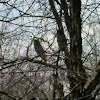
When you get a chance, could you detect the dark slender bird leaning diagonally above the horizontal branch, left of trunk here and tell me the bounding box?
[34,39,46,61]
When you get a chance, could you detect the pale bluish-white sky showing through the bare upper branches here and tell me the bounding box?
[0,0,100,59]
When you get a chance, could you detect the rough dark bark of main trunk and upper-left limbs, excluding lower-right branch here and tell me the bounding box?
[49,0,87,100]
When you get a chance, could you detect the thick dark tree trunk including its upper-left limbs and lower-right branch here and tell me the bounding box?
[49,0,100,100]
